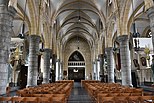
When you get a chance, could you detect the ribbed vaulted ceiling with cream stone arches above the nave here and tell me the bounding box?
[13,0,149,50]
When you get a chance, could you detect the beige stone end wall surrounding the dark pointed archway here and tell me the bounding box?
[63,38,92,77]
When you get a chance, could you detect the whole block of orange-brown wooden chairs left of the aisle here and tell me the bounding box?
[0,81,74,103]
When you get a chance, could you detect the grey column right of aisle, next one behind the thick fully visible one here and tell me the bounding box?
[105,47,114,83]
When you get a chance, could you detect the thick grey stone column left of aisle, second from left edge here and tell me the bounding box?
[27,35,40,87]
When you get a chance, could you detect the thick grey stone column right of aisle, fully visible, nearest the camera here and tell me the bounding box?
[118,35,132,86]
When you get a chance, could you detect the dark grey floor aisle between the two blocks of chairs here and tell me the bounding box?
[68,82,96,103]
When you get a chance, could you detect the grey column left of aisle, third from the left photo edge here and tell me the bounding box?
[42,49,51,84]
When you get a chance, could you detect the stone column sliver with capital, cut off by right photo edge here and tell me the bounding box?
[147,6,154,51]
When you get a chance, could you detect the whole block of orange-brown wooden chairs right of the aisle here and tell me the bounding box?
[83,81,154,103]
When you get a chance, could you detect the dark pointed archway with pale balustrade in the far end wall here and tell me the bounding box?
[68,51,85,82]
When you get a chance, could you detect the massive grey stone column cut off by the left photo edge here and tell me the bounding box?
[0,0,17,95]
